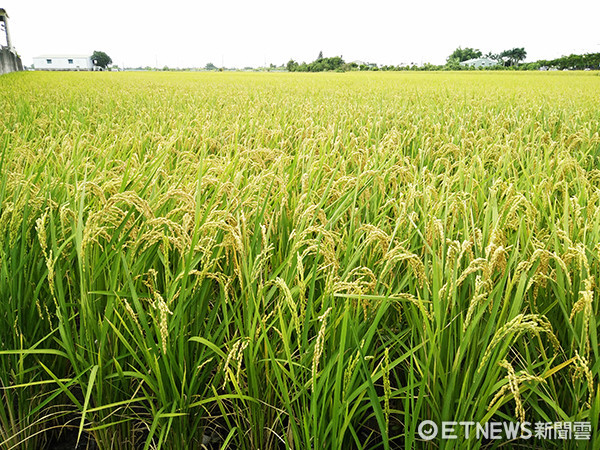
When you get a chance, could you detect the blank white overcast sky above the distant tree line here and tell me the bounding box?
[0,0,600,67]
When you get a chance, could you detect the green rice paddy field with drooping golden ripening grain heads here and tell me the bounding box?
[0,72,600,450]
